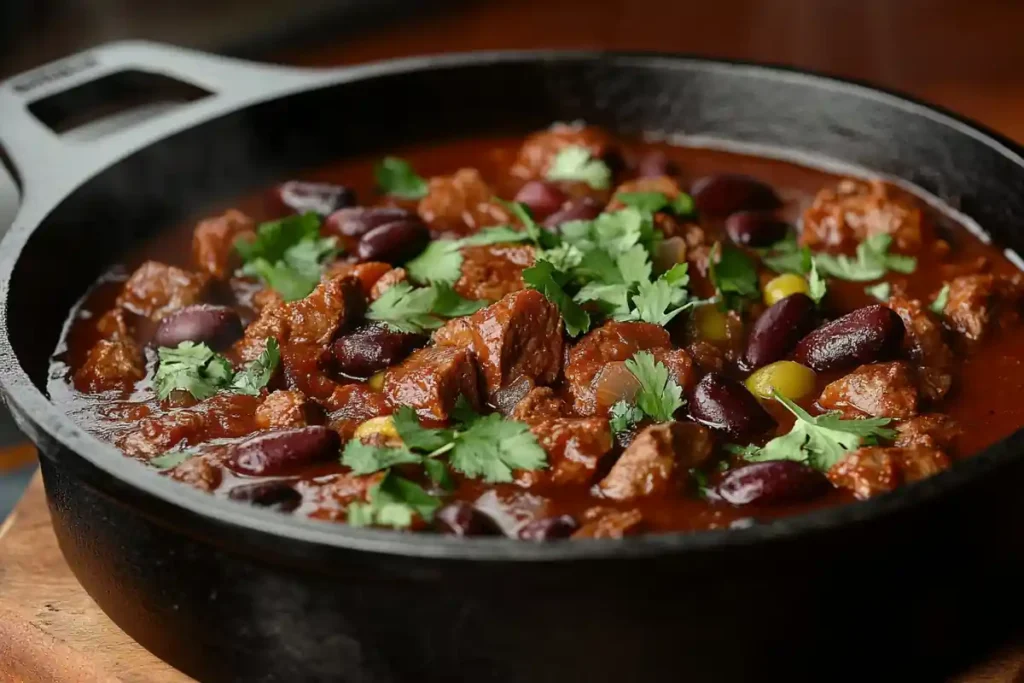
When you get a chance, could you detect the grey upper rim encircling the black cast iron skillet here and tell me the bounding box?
[0,49,1024,562]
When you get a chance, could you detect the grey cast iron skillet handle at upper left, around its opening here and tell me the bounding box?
[0,41,323,216]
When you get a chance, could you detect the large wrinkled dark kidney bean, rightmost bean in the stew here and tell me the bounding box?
[795,305,905,371]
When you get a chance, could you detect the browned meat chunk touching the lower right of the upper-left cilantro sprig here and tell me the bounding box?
[285,275,367,344]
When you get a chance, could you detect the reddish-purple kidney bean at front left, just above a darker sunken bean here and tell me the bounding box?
[227,426,341,476]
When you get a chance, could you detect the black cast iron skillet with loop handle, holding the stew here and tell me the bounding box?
[0,43,1024,683]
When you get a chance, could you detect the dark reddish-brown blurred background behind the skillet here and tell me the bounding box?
[0,0,1024,518]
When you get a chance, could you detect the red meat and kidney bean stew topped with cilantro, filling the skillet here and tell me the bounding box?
[49,124,1024,541]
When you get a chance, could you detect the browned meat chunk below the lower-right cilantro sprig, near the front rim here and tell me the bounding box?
[828,446,950,500]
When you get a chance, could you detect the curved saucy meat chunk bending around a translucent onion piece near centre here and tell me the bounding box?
[565,322,672,415]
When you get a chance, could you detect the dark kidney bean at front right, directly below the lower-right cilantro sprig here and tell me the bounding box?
[718,460,828,505]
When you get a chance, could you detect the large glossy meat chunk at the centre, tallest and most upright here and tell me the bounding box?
[460,290,562,396]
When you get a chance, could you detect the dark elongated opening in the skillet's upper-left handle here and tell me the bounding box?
[29,70,212,138]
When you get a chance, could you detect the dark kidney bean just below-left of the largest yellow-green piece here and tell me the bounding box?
[690,373,774,439]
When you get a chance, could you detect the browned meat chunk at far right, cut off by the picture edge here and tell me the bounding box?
[944,273,1024,340]
